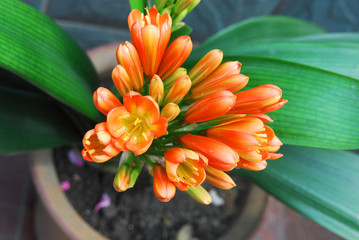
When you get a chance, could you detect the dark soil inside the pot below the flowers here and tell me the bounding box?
[55,148,250,240]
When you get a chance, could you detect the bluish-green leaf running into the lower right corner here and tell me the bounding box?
[239,146,359,240]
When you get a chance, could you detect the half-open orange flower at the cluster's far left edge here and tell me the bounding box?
[82,122,122,163]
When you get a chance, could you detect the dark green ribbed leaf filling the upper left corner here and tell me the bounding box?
[0,0,99,119]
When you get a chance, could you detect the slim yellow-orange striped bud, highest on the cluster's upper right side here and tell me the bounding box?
[188,49,223,86]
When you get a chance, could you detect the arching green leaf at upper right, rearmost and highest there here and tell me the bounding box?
[190,16,325,61]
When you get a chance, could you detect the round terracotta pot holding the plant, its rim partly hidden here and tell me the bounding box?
[31,44,268,240]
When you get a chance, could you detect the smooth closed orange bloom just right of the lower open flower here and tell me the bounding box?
[180,134,239,171]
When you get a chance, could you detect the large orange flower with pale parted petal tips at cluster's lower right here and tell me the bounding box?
[207,117,282,162]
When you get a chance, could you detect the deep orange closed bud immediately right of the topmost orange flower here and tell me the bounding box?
[157,36,192,79]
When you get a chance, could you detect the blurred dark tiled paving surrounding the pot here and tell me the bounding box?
[0,0,359,240]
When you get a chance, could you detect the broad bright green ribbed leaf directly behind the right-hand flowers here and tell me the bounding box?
[224,56,359,149]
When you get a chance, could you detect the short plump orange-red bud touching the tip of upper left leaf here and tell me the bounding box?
[93,87,122,115]
